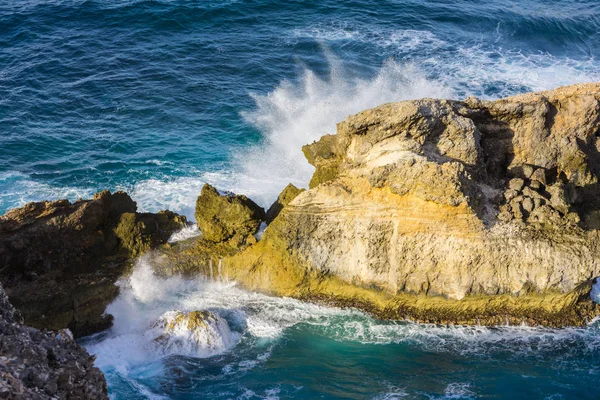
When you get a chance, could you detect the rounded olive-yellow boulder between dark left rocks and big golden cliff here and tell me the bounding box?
[195,184,265,243]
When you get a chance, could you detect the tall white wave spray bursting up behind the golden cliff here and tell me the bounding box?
[209,56,452,206]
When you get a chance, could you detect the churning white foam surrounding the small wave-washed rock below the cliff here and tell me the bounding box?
[86,253,354,375]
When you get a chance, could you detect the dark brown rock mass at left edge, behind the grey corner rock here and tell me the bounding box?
[0,191,186,336]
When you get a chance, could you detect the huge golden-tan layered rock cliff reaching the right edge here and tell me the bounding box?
[165,84,600,326]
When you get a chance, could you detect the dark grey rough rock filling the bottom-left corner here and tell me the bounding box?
[0,286,108,400]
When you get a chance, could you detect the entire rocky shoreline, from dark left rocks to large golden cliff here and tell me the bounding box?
[0,84,600,398]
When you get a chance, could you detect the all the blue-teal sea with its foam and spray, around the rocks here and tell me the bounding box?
[0,0,600,400]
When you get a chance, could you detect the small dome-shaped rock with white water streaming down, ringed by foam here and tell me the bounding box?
[153,310,235,356]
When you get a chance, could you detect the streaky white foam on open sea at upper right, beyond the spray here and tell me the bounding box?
[289,22,600,98]
